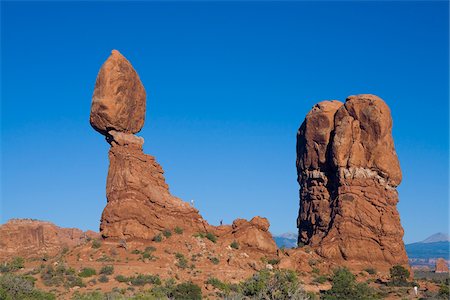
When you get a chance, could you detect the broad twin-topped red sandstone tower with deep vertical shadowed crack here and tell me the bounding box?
[297,95,408,270]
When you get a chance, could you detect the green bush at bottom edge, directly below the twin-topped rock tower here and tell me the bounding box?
[323,268,379,300]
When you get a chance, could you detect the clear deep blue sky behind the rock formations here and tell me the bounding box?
[1,1,449,243]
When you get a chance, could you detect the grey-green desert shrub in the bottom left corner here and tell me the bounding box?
[0,274,56,300]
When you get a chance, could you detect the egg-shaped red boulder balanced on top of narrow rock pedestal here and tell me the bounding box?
[90,50,146,135]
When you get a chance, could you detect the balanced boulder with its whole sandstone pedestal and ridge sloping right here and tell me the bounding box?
[91,50,277,253]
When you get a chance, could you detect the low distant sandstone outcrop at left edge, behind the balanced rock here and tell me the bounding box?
[0,219,99,260]
